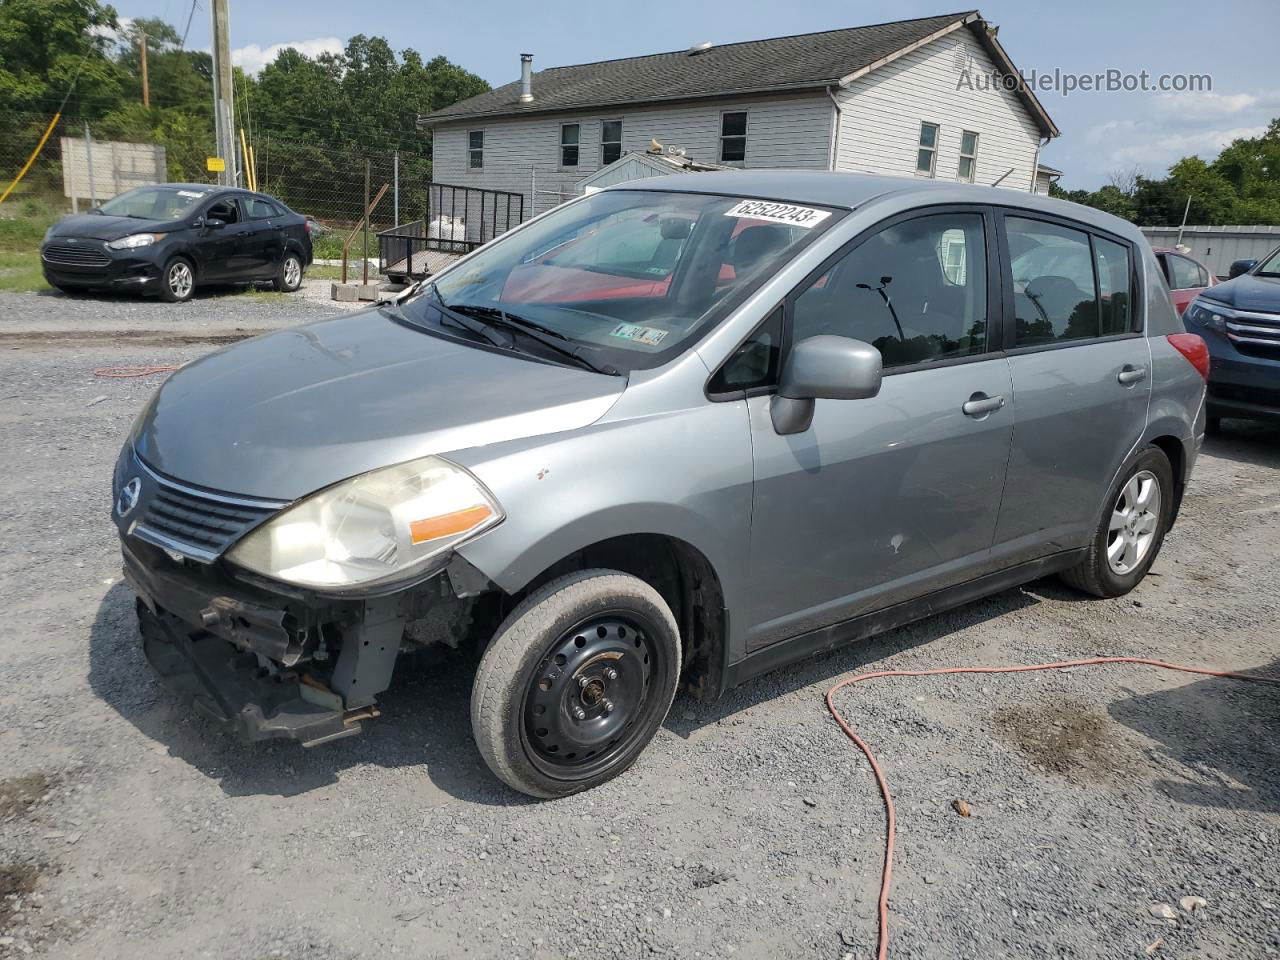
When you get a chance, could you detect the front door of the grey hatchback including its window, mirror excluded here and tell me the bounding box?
[748,207,1012,650]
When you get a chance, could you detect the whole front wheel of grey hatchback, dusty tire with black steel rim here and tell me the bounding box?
[471,570,681,797]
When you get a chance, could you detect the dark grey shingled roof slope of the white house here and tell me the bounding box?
[421,10,977,124]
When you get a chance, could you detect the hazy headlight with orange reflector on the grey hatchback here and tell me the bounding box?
[227,457,502,588]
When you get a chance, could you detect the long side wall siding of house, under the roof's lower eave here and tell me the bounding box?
[431,88,832,212]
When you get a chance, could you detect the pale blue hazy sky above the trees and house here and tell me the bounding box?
[113,0,1280,189]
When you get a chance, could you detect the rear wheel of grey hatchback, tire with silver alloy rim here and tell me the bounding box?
[1061,447,1174,596]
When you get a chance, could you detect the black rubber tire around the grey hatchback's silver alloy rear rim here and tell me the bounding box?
[1059,447,1174,596]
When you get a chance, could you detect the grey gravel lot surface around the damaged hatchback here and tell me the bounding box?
[0,294,1280,960]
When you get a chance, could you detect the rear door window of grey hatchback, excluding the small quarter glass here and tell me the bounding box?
[1005,216,1100,347]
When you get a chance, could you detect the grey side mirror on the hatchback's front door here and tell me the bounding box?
[769,335,882,434]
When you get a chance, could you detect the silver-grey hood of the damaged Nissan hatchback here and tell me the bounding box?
[133,311,626,500]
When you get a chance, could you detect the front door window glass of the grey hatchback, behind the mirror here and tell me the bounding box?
[792,214,987,367]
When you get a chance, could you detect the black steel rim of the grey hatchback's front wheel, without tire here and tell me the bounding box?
[520,611,669,780]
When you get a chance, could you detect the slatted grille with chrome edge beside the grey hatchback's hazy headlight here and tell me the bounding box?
[133,467,287,563]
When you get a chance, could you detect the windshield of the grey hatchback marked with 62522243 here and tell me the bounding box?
[404,191,838,370]
